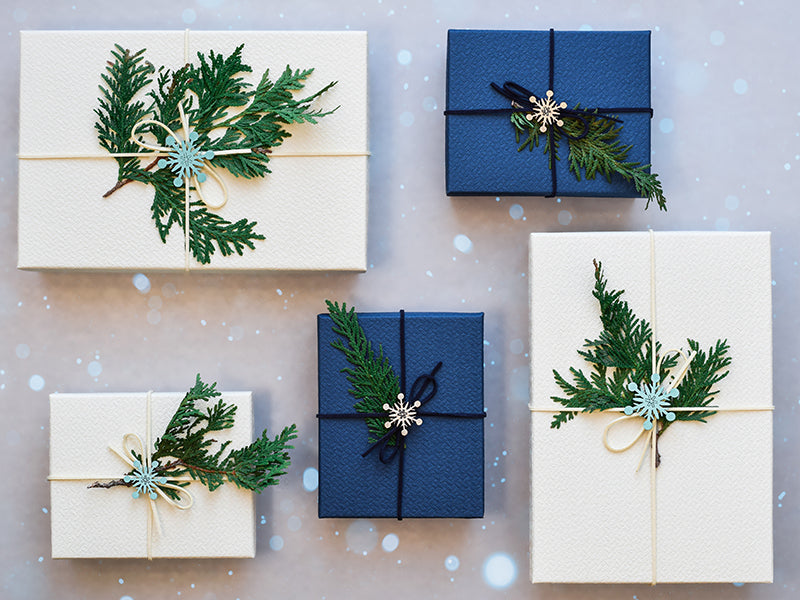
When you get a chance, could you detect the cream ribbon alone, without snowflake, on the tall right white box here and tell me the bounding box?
[528,229,775,585]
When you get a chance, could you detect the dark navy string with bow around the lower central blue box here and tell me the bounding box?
[317,310,486,521]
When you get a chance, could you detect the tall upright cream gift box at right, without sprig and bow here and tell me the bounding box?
[530,232,772,583]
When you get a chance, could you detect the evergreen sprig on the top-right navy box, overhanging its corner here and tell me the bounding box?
[511,105,667,210]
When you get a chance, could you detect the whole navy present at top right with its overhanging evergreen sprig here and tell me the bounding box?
[445,30,665,208]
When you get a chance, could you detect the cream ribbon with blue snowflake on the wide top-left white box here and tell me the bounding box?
[17,29,370,271]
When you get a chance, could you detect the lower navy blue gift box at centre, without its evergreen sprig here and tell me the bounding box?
[317,313,485,518]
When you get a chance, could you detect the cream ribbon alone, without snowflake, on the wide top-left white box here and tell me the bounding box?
[17,29,370,271]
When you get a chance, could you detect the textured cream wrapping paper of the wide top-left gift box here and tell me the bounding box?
[18,31,367,271]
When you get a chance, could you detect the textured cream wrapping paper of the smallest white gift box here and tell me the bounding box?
[50,392,255,558]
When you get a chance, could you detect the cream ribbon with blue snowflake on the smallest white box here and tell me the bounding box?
[47,391,194,560]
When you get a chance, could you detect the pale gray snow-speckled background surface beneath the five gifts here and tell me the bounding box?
[0,0,800,600]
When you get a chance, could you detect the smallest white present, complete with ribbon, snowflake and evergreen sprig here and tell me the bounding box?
[49,377,296,558]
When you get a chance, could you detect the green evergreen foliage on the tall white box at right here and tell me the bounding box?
[550,262,731,435]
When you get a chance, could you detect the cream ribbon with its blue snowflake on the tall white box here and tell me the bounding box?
[528,229,775,585]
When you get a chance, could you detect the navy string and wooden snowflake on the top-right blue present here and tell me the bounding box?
[444,29,653,198]
